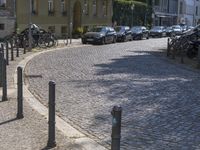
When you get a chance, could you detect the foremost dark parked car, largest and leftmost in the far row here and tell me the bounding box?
[82,26,117,44]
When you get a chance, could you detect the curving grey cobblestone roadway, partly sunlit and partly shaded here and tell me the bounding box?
[26,38,200,150]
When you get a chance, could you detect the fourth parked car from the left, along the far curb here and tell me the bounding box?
[149,26,166,37]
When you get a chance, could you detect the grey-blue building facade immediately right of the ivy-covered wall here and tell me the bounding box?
[152,0,178,26]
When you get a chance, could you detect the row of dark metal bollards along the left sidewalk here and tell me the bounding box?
[0,44,122,150]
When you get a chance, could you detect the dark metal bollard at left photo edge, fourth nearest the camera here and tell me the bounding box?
[2,58,8,101]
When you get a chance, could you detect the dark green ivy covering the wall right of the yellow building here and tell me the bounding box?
[113,0,152,26]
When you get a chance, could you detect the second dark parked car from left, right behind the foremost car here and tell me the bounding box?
[115,26,132,42]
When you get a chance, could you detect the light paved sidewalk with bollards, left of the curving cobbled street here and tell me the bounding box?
[0,39,105,150]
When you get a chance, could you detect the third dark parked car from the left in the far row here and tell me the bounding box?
[131,26,149,40]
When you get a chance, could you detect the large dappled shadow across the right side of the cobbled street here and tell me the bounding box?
[66,51,200,149]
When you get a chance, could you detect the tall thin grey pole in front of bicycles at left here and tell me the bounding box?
[28,0,32,51]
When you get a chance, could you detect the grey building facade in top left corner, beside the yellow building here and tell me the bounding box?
[0,0,15,38]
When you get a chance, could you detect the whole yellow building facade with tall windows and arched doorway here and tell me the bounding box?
[16,0,113,35]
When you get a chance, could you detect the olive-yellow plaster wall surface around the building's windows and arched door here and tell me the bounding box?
[16,0,112,35]
